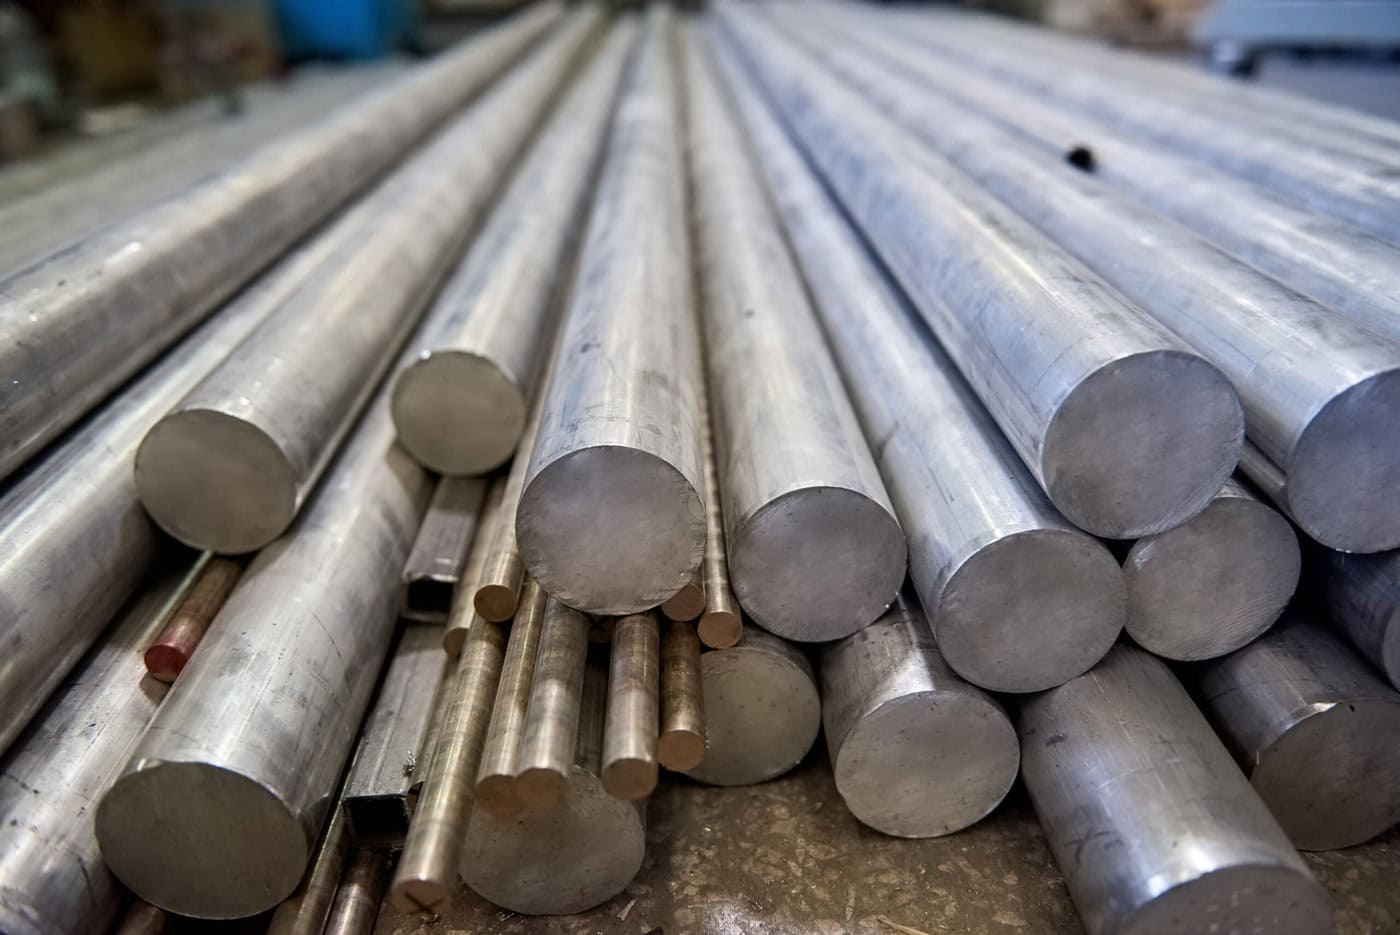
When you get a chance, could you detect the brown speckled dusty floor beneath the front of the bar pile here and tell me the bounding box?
[377,750,1400,935]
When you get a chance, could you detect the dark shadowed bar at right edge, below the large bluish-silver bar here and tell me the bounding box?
[1313,549,1400,689]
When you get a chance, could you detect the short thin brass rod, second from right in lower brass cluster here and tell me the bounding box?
[599,613,661,801]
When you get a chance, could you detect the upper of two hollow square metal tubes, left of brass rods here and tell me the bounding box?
[399,477,487,623]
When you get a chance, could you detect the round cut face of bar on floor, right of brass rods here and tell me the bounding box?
[833,691,1021,837]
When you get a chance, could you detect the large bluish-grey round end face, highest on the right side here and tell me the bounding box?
[1040,350,1245,539]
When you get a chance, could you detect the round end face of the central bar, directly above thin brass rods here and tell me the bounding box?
[517,445,706,616]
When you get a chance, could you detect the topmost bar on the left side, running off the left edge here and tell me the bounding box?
[0,3,561,489]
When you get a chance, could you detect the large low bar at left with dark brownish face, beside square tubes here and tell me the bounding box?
[97,395,433,918]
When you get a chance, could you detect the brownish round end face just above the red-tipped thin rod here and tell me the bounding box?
[136,409,298,556]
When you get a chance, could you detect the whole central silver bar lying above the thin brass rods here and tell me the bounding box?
[515,4,704,614]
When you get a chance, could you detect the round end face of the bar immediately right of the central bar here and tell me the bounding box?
[729,487,907,642]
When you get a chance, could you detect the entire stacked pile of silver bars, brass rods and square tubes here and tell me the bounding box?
[0,0,1400,935]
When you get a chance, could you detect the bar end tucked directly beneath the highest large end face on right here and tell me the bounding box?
[1123,480,1302,661]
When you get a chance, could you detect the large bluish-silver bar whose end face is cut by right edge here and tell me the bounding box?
[784,5,1400,551]
